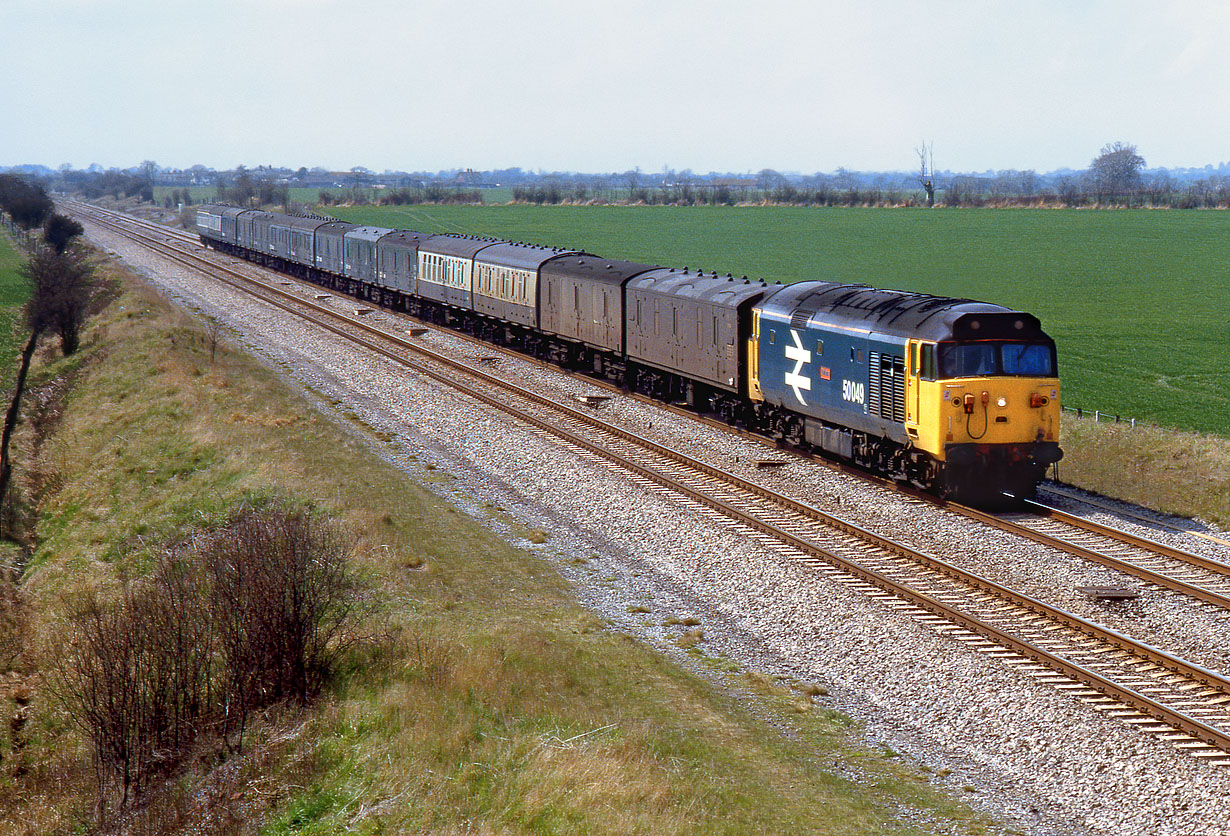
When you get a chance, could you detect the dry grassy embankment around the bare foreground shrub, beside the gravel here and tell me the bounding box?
[0,242,985,835]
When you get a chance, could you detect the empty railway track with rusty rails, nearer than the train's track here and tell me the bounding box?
[71,205,1230,765]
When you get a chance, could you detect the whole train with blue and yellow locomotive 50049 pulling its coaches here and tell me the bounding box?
[197,204,1063,508]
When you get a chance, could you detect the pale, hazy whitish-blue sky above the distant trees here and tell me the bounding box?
[0,0,1230,173]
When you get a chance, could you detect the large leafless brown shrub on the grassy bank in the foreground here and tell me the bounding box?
[49,507,359,816]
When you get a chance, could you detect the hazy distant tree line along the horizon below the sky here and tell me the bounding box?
[14,141,1230,209]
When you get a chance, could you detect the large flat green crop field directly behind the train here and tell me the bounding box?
[323,205,1230,435]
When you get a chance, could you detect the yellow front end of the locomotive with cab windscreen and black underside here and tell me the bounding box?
[905,331,1063,507]
